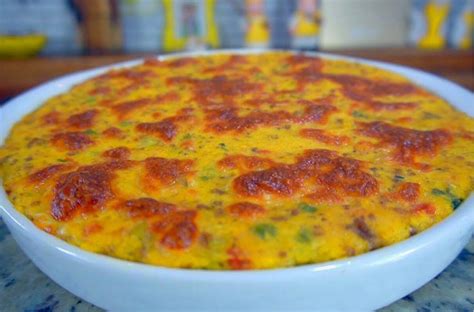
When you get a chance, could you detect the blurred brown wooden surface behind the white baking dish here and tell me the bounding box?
[0,49,474,99]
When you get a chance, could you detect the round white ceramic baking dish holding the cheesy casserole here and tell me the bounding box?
[0,50,474,311]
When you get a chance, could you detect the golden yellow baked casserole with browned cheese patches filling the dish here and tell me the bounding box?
[0,53,474,270]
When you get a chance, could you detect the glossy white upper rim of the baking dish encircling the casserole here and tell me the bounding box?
[0,49,474,281]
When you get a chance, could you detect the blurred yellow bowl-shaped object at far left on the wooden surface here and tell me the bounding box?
[0,34,46,58]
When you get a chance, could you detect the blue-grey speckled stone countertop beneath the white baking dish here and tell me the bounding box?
[0,219,474,312]
